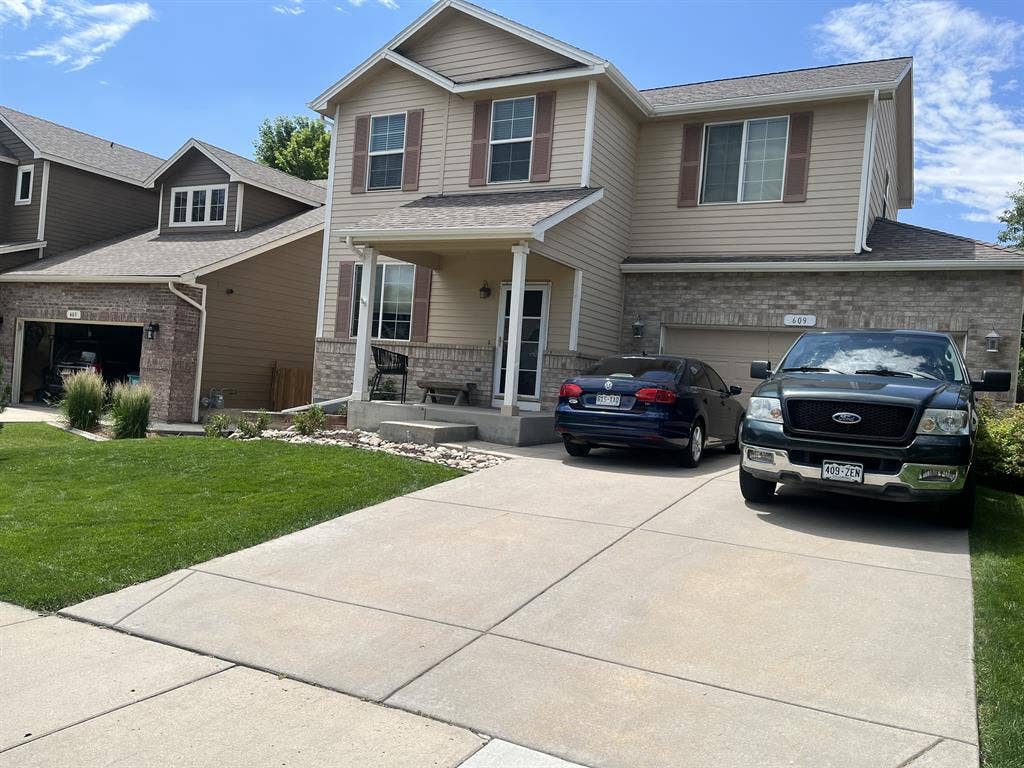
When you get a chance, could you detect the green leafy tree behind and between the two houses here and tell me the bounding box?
[253,115,331,179]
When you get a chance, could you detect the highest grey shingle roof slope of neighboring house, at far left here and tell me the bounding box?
[0,106,164,183]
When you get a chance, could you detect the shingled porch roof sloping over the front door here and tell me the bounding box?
[333,186,604,244]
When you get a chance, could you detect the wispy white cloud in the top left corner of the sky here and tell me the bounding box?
[0,0,154,72]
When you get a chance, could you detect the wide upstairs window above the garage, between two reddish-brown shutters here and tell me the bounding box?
[700,117,790,203]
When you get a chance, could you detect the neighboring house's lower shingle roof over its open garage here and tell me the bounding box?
[0,208,324,282]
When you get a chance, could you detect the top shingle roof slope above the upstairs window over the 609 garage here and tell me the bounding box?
[640,57,913,106]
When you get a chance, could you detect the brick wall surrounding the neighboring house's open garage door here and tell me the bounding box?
[0,283,200,422]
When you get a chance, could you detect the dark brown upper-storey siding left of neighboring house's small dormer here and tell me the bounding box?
[44,162,159,256]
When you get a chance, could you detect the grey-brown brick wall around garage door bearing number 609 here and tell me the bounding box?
[622,270,1024,399]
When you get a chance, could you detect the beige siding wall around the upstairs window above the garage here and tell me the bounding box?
[630,99,867,257]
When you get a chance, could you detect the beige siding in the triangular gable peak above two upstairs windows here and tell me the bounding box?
[398,10,579,83]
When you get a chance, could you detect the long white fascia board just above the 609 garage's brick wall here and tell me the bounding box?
[620,258,1024,274]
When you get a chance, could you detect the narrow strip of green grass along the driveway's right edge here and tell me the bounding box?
[971,487,1024,768]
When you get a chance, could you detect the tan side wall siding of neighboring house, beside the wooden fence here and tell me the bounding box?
[203,233,323,408]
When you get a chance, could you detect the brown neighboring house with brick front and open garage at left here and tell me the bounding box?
[0,115,325,422]
